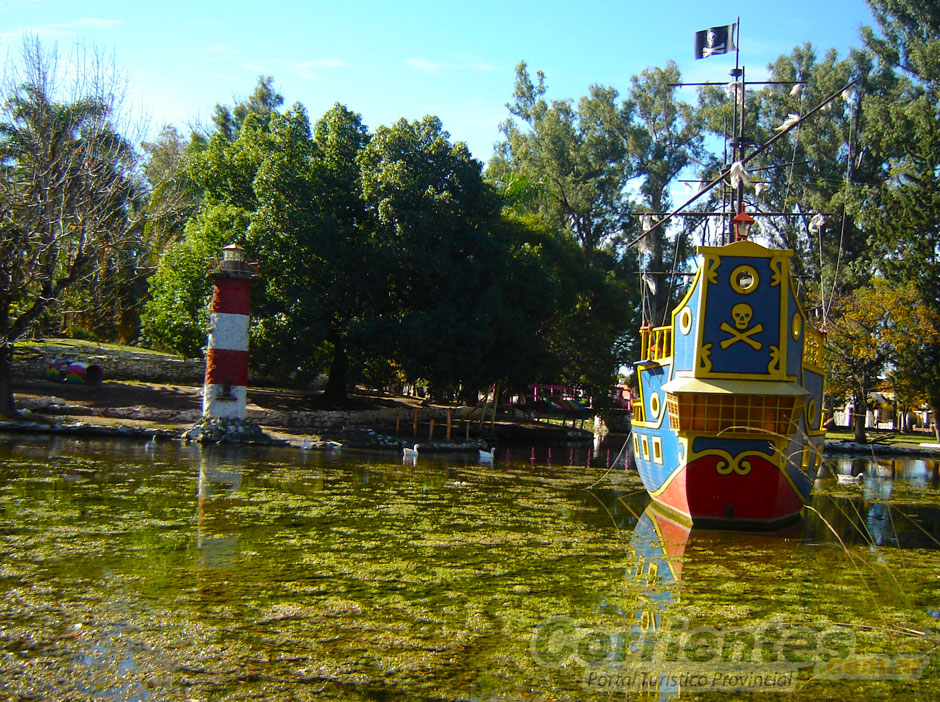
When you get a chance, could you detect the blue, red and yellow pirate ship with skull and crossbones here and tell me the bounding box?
[632,20,832,529]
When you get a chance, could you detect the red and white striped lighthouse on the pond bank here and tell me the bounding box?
[202,244,256,419]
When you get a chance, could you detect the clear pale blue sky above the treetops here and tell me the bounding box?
[0,0,873,161]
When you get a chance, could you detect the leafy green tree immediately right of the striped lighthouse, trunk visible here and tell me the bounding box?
[249,105,376,401]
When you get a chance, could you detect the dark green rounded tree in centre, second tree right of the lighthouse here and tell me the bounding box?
[359,117,503,398]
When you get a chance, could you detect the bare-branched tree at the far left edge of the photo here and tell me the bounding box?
[0,41,139,416]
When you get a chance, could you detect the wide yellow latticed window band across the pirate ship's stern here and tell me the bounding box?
[666,392,802,436]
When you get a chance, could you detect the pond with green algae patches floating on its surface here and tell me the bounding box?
[0,436,940,701]
